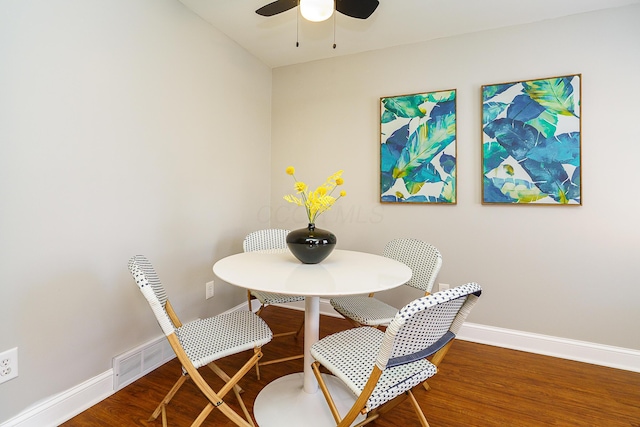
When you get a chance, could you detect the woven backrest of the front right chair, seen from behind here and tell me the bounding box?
[376,283,482,370]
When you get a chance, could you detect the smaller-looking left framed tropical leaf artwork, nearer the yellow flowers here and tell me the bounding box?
[380,89,456,204]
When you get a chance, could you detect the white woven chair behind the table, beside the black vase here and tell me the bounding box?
[242,228,304,379]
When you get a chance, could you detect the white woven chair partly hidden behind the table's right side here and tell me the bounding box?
[331,239,442,327]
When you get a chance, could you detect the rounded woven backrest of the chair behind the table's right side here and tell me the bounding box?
[382,239,442,292]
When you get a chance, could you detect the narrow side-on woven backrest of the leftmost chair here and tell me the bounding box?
[129,255,175,336]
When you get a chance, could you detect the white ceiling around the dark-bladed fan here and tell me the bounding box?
[180,0,640,68]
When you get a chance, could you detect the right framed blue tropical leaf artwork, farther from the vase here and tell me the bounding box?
[482,74,582,206]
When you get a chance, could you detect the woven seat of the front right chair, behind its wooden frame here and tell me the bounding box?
[311,326,437,412]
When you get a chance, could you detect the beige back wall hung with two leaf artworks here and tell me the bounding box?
[271,6,640,350]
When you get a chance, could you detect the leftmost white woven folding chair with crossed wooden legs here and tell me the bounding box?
[129,255,273,427]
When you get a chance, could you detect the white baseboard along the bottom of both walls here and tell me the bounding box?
[0,299,640,427]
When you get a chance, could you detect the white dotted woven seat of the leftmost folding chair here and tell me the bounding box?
[176,311,272,368]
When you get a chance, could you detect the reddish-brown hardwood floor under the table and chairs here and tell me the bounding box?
[62,307,640,427]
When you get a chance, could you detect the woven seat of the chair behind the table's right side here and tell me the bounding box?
[331,295,398,326]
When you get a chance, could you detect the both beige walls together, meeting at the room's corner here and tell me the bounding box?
[5,0,640,423]
